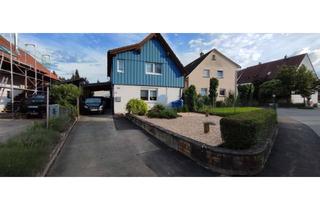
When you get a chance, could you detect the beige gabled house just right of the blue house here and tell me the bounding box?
[185,49,241,101]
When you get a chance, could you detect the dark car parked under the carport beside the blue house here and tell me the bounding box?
[83,97,106,114]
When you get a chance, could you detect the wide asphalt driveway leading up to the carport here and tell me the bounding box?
[49,115,218,176]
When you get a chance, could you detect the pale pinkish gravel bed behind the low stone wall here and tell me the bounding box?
[138,112,222,146]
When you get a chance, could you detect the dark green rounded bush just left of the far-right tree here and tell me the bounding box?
[259,79,282,101]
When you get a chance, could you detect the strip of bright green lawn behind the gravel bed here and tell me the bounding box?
[202,107,261,117]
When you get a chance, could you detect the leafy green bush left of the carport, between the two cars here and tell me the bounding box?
[50,84,80,116]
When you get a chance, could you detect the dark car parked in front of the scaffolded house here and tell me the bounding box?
[26,95,47,118]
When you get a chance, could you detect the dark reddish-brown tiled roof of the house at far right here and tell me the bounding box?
[237,54,307,84]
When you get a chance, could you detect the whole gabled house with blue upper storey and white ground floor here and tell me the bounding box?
[108,33,185,113]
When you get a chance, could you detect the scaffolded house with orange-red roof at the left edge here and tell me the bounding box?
[0,36,58,112]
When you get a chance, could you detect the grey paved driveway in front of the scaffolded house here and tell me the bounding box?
[0,119,34,143]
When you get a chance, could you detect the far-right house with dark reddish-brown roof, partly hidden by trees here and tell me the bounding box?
[237,53,318,104]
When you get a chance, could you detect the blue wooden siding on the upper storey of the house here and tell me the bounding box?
[112,39,184,87]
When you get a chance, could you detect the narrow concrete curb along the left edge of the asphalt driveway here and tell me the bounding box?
[40,118,78,177]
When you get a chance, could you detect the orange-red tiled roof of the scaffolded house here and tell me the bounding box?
[0,35,58,80]
